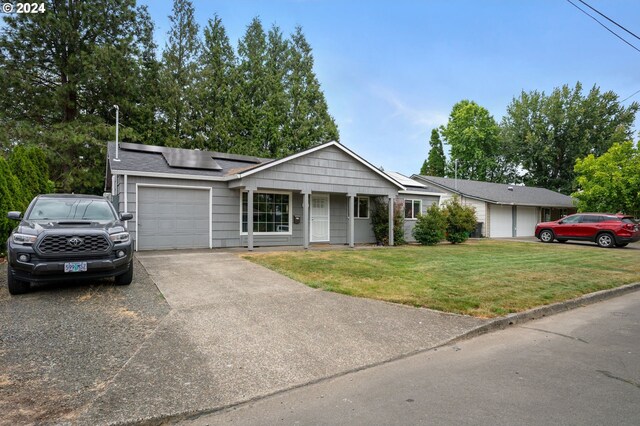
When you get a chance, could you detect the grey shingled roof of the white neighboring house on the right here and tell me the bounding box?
[411,175,575,208]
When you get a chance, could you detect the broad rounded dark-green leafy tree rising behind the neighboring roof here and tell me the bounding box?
[502,83,640,194]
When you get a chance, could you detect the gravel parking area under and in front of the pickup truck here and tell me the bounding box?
[0,260,169,425]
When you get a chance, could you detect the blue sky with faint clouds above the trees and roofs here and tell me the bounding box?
[139,0,640,175]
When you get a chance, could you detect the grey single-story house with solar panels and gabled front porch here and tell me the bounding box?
[106,142,412,250]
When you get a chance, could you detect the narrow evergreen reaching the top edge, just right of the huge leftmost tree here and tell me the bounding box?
[161,0,200,147]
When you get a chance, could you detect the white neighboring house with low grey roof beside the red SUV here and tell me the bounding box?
[411,175,576,238]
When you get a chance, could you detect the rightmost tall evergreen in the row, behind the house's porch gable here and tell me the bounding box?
[279,27,340,156]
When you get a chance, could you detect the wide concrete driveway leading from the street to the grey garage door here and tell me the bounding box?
[80,251,487,423]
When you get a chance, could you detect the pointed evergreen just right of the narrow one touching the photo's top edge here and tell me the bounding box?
[195,15,238,152]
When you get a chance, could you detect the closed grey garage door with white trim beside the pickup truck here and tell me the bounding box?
[137,186,211,250]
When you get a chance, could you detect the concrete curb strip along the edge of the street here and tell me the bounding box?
[120,282,640,426]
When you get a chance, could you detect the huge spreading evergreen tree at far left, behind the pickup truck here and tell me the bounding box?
[0,0,155,192]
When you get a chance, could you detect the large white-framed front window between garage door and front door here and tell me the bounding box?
[242,192,291,233]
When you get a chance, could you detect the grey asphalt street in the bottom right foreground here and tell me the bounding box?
[183,292,640,425]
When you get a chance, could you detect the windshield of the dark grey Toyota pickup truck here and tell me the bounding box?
[27,198,116,221]
